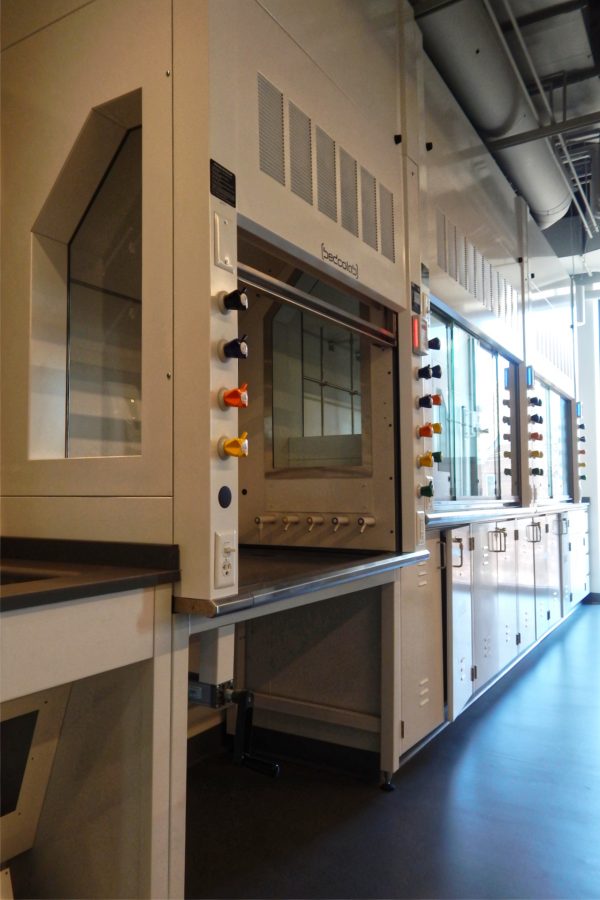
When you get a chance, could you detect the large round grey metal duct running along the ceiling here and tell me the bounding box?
[418,0,572,228]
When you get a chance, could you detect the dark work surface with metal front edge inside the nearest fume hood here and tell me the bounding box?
[173,547,429,618]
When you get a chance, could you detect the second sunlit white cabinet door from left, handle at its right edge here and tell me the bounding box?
[471,524,500,690]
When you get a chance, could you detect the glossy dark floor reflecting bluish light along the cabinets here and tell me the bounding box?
[186,606,600,900]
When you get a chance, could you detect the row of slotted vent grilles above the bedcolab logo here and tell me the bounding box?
[258,74,396,262]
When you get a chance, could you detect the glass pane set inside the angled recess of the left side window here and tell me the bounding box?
[67,128,142,457]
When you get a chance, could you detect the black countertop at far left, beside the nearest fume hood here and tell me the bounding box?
[0,537,181,612]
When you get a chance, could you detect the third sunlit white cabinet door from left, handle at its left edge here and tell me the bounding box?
[492,522,517,669]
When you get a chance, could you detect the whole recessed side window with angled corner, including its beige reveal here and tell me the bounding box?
[29,91,142,459]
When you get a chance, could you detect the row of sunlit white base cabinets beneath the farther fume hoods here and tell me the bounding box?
[445,509,589,721]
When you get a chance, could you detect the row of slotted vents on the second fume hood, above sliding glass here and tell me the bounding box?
[437,210,521,325]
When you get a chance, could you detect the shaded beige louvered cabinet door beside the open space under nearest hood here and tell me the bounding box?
[400,540,444,753]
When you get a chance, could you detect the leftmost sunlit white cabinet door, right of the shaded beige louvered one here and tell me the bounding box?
[446,525,473,721]
